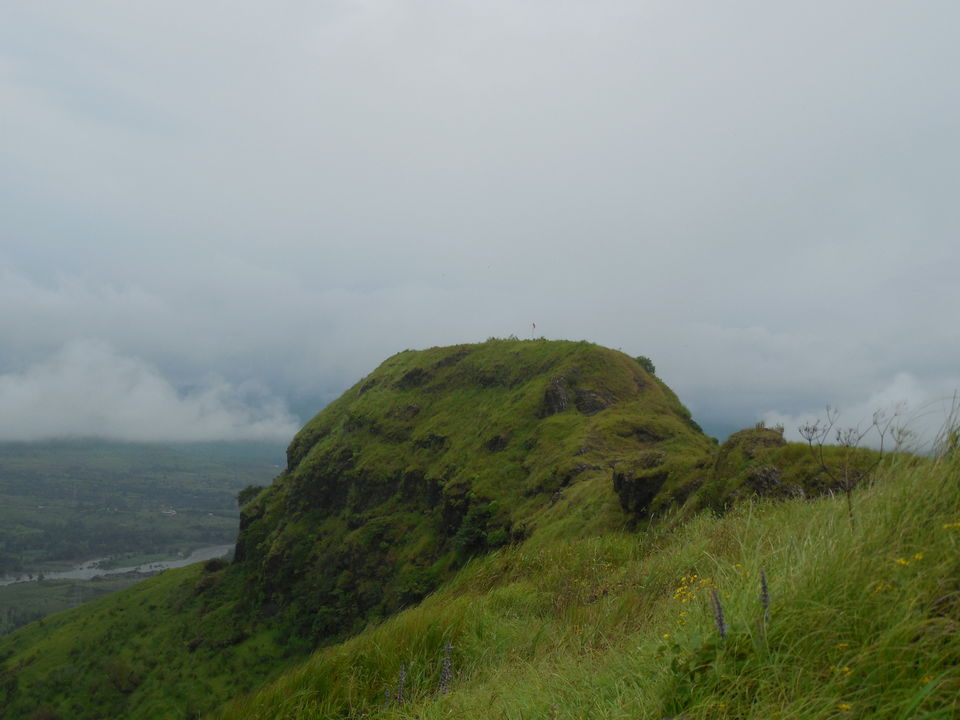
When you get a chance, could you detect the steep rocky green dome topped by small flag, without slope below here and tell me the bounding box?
[236,341,712,640]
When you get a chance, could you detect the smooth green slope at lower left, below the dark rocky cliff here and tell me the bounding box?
[0,561,295,720]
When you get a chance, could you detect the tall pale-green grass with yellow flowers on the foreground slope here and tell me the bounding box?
[219,457,960,720]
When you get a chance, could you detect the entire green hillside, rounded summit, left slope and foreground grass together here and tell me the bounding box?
[0,340,960,720]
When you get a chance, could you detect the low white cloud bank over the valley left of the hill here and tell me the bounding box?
[0,341,298,442]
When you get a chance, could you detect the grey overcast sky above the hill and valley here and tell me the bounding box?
[0,0,960,448]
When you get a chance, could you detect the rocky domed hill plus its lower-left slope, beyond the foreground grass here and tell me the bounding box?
[0,340,892,720]
